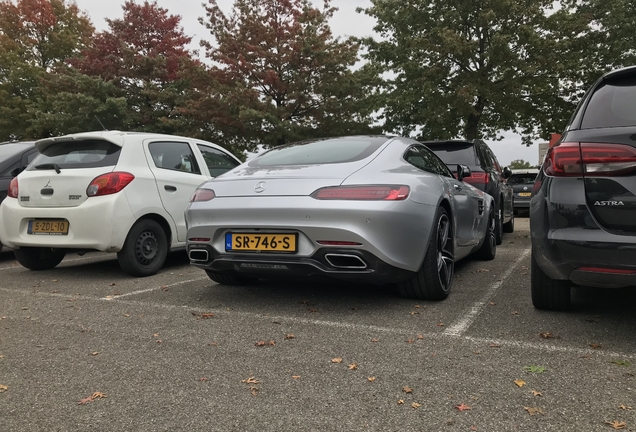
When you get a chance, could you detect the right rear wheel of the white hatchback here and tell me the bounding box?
[117,219,168,277]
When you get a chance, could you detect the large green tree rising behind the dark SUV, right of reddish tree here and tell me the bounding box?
[364,0,592,144]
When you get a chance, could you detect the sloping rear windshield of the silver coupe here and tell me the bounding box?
[249,137,387,166]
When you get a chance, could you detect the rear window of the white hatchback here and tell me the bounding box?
[27,140,121,171]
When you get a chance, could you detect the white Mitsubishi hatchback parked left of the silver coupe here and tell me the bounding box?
[0,131,241,276]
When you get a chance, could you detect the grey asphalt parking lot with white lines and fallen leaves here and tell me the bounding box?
[0,218,636,432]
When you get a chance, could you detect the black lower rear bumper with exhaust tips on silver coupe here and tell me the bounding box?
[187,243,413,285]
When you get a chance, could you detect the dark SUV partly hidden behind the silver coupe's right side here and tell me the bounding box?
[424,140,515,244]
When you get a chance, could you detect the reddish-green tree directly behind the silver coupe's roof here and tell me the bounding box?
[200,0,372,152]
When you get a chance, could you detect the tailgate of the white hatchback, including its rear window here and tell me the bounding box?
[18,139,121,207]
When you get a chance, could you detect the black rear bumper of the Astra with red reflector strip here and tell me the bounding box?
[530,176,636,288]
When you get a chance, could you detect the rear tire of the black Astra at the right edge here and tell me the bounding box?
[530,253,572,310]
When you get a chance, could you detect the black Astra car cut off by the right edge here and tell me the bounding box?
[530,66,636,310]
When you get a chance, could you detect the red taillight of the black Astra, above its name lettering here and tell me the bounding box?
[543,143,636,177]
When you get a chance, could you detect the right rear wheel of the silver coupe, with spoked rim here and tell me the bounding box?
[398,207,455,300]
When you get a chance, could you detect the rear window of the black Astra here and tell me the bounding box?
[581,76,636,129]
